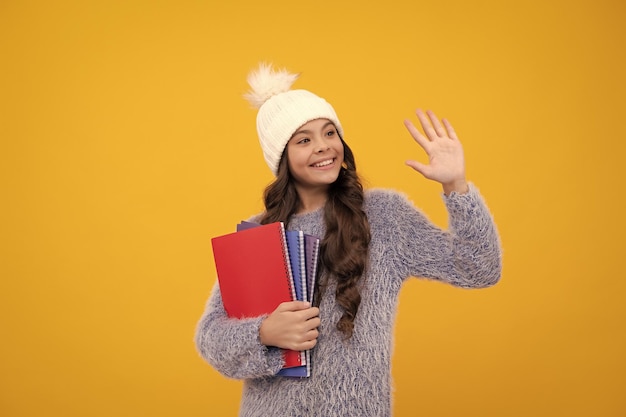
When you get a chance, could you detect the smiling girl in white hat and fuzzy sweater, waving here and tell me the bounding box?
[196,65,501,417]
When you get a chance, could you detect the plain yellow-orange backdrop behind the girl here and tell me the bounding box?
[0,0,626,417]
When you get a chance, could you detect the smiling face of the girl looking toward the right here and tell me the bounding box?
[287,119,343,191]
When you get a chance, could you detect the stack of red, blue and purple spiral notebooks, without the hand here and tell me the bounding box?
[211,222,320,378]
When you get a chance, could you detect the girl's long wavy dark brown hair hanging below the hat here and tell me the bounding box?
[261,139,371,338]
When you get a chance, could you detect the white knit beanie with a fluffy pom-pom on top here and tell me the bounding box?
[244,63,343,175]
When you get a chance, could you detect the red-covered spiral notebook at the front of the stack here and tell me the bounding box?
[211,222,303,368]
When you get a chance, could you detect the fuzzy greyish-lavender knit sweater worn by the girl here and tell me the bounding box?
[196,184,501,417]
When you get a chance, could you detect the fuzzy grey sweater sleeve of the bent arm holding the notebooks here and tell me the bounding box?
[195,283,283,379]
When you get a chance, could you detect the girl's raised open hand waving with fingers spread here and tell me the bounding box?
[404,109,468,194]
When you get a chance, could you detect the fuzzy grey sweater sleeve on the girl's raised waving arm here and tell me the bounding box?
[372,184,502,288]
